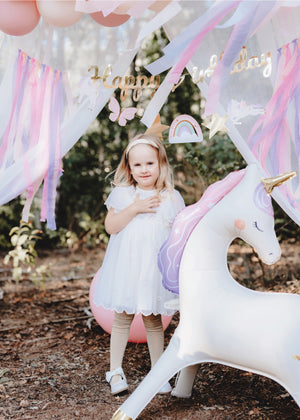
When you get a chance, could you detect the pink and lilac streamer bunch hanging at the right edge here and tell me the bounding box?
[248,40,300,209]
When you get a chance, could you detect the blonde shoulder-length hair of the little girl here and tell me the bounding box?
[114,134,174,191]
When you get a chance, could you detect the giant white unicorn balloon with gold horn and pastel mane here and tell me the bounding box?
[112,164,300,420]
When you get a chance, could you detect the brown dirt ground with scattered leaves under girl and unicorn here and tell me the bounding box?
[0,243,300,420]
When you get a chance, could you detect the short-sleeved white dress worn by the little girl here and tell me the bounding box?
[94,186,184,315]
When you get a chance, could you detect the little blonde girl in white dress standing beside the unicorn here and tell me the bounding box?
[94,134,184,394]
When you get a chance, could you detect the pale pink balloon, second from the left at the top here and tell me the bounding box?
[37,0,83,28]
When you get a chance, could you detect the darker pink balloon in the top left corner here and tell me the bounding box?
[0,0,40,36]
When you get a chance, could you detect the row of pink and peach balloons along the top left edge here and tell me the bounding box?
[0,0,170,36]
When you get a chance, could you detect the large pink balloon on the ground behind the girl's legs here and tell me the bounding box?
[89,277,172,343]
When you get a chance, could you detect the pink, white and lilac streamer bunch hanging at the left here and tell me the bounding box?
[0,50,64,229]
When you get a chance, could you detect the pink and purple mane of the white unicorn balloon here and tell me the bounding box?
[158,169,245,294]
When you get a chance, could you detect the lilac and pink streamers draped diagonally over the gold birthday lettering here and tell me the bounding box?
[144,0,276,123]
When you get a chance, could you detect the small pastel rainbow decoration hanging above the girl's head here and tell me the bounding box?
[169,114,203,143]
